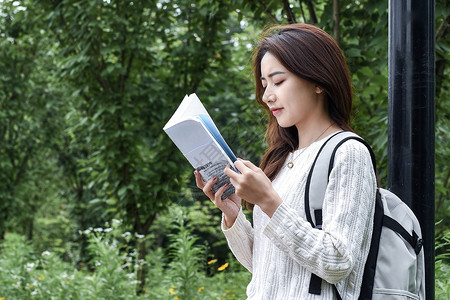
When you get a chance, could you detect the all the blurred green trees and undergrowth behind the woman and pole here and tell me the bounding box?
[0,0,450,300]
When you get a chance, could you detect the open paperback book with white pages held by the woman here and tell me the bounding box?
[163,94,236,199]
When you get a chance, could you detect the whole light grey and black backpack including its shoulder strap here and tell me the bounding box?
[305,131,425,300]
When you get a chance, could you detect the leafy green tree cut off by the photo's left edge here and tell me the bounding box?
[0,1,65,239]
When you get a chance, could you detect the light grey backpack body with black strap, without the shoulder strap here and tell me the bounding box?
[372,189,425,300]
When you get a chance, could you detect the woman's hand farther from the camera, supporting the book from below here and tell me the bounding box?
[194,170,242,228]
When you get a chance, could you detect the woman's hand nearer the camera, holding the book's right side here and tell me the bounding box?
[224,159,283,217]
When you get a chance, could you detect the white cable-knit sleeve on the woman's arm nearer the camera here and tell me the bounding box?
[264,141,376,285]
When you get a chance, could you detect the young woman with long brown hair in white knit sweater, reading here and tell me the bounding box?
[195,24,376,300]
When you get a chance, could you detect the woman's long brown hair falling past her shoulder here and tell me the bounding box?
[253,24,352,180]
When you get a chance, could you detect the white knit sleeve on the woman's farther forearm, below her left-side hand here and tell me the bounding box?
[222,208,253,272]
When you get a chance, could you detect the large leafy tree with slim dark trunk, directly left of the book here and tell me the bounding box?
[28,1,253,290]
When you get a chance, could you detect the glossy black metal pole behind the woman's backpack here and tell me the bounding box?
[388,0,435,299]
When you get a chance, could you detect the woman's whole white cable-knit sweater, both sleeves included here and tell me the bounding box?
[222,137,376,300]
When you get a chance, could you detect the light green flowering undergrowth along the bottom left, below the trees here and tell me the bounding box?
[0,207,250,300]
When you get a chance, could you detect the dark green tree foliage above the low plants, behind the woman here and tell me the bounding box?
[0,0,450,296]
